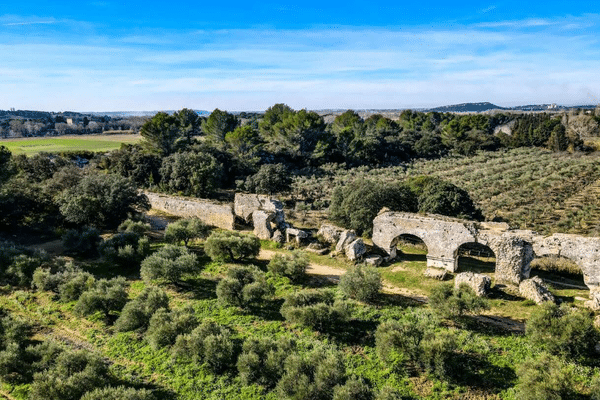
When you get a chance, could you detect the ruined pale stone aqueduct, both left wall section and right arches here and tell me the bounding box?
[146,192,600,308]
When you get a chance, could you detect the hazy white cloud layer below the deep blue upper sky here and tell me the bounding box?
[0,16,600,110]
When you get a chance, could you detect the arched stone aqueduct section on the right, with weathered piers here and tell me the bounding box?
[373,211,600,292]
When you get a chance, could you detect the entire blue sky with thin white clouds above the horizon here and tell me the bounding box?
[0,0,600,111]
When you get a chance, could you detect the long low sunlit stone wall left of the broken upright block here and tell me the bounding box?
[145,192,235,230]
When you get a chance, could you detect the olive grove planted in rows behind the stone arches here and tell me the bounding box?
[294,148,600,235]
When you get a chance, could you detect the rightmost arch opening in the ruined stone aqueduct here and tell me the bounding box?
[529,255,589,291]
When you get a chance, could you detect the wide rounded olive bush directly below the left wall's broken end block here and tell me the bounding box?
[204,231,260,261]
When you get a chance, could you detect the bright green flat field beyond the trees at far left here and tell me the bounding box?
[0,135,141,156]
